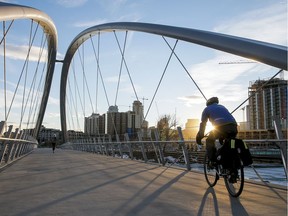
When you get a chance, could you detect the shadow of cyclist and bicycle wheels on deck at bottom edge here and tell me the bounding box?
[197,187,249,216]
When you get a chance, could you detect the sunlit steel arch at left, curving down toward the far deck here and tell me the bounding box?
[0,2,57,137]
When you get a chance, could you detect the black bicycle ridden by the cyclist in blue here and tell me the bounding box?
[204,139,244,197]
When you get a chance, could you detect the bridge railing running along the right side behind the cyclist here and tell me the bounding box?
[61,139,287,174]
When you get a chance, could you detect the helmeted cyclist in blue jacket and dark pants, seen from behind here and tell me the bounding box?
[196,97,238,164]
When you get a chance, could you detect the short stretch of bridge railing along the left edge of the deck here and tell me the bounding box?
[0,136,38,169]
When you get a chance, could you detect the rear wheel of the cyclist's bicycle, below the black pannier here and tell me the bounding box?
[224,161,244,197]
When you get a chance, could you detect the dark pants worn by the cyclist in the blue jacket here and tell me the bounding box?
[206,124,238,161]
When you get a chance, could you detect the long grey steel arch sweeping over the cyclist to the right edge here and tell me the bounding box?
[60,22,287,142]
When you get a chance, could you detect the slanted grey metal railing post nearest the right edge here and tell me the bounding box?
[273,117,288,179]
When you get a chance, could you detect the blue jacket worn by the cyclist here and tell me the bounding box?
[201,103,237,126]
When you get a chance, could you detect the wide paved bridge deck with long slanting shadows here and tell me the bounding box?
[0,149,287,216]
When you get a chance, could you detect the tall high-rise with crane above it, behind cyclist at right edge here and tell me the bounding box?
[247,78,287,130]
